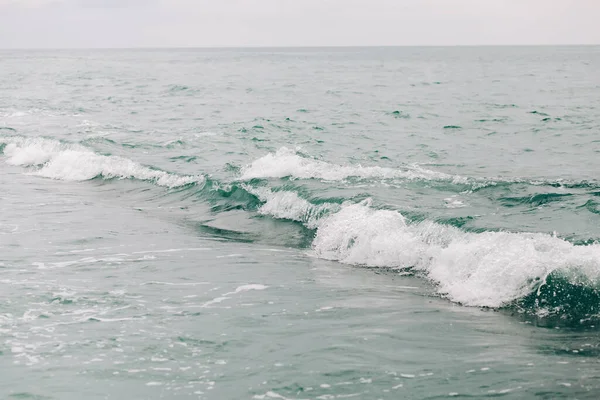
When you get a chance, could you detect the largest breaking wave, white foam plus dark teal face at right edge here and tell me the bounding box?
[233,184,600,314]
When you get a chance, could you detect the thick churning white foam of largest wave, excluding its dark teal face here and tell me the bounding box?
[313,200,600,307]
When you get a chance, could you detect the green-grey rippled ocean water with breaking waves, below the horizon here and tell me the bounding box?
[0,47,600,400]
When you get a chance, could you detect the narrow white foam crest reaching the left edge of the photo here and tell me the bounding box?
[0,136,205,188]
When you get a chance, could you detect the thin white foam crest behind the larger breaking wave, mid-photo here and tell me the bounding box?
[240,147,469,183]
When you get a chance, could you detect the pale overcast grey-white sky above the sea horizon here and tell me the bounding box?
[0,0,600,48]
